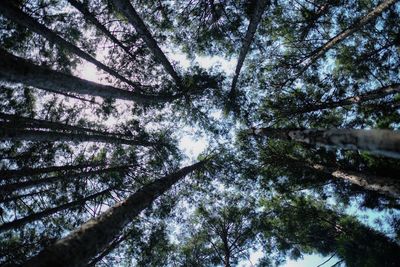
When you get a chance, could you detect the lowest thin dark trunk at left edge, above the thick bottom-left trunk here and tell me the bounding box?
[0,188,112,232]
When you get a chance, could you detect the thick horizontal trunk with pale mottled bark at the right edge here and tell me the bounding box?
[250,128,400,158]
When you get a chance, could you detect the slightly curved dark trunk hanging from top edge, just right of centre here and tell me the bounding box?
[229,0,269,100]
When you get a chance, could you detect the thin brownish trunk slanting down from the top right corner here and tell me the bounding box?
[301,0,396,70]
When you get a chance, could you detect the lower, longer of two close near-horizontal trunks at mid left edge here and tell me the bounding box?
[0,128,157,146]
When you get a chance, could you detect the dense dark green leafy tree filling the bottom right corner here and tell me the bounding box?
[263,198,400,266]
